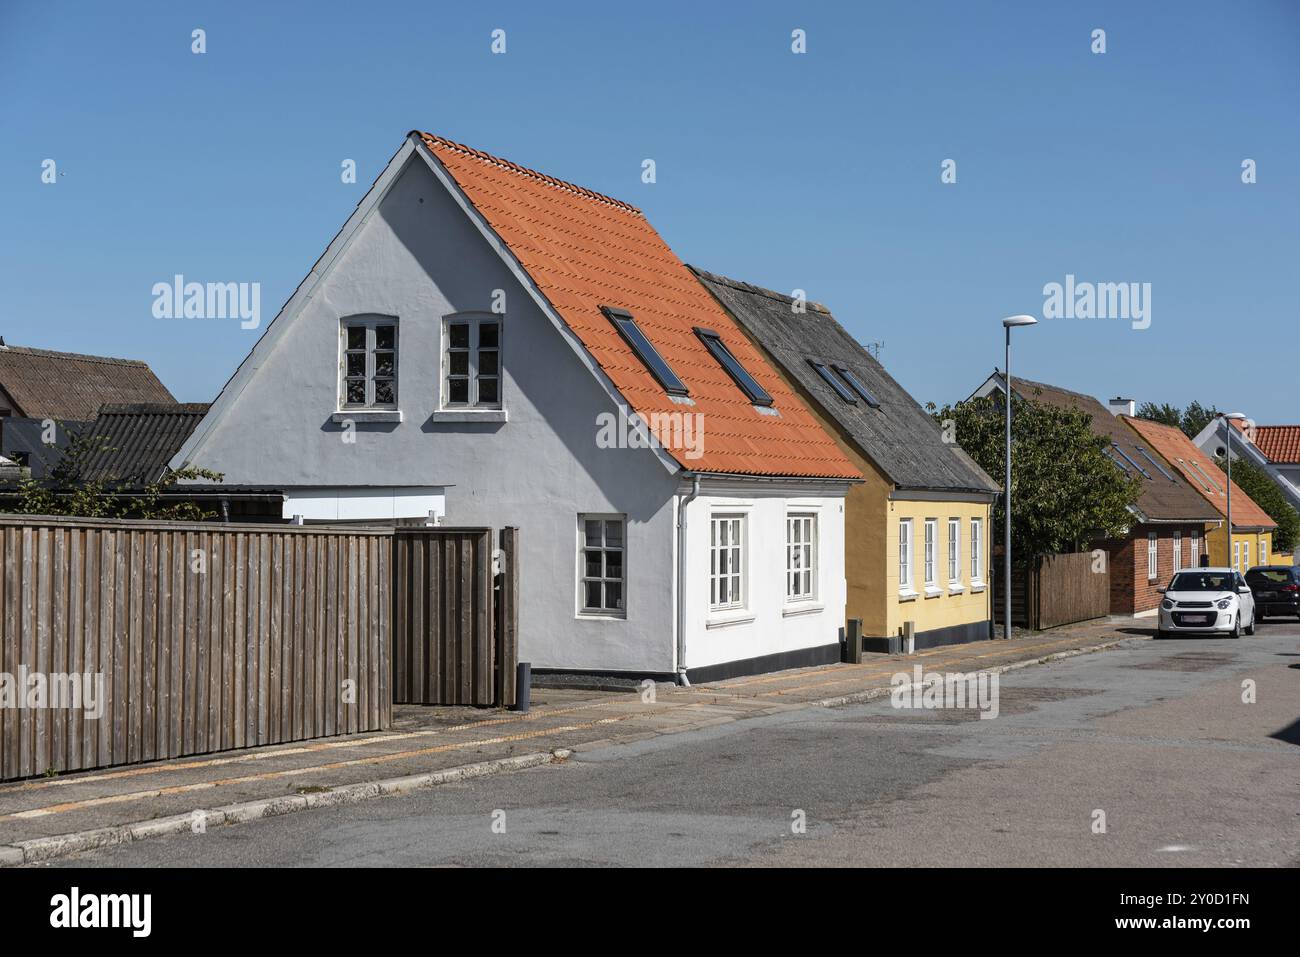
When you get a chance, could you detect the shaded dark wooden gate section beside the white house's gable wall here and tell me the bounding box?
[393,528,519,706]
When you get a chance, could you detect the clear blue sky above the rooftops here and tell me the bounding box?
[0,0,1300,423]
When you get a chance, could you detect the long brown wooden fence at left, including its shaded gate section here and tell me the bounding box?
[0,518,519,780]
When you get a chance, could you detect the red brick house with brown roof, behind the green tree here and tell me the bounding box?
[972,372,1222,616]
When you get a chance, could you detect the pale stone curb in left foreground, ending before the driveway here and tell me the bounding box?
[0,748,572,867]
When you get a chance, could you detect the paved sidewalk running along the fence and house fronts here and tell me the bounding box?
[0,619,1149,865]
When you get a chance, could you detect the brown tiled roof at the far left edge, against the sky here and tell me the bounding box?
[0,346,176,421]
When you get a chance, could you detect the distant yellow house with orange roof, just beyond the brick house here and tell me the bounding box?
[1121,416,1278,575]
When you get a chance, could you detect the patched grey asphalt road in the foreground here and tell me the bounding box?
[40,623,1300,867]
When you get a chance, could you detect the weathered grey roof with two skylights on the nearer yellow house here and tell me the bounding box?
[690,267,1001,493]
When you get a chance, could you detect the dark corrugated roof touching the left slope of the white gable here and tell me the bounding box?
[82,402,208,485]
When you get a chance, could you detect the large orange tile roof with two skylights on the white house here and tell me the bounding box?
[419,133,861,479]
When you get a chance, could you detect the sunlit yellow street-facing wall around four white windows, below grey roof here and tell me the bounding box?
[884,499,993,635]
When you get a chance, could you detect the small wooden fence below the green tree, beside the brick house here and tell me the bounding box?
[993,551,1110,631]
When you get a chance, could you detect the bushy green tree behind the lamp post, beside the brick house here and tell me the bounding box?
[933,397,1139,559]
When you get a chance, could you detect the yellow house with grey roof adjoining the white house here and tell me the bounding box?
[696,269,1000,650]
